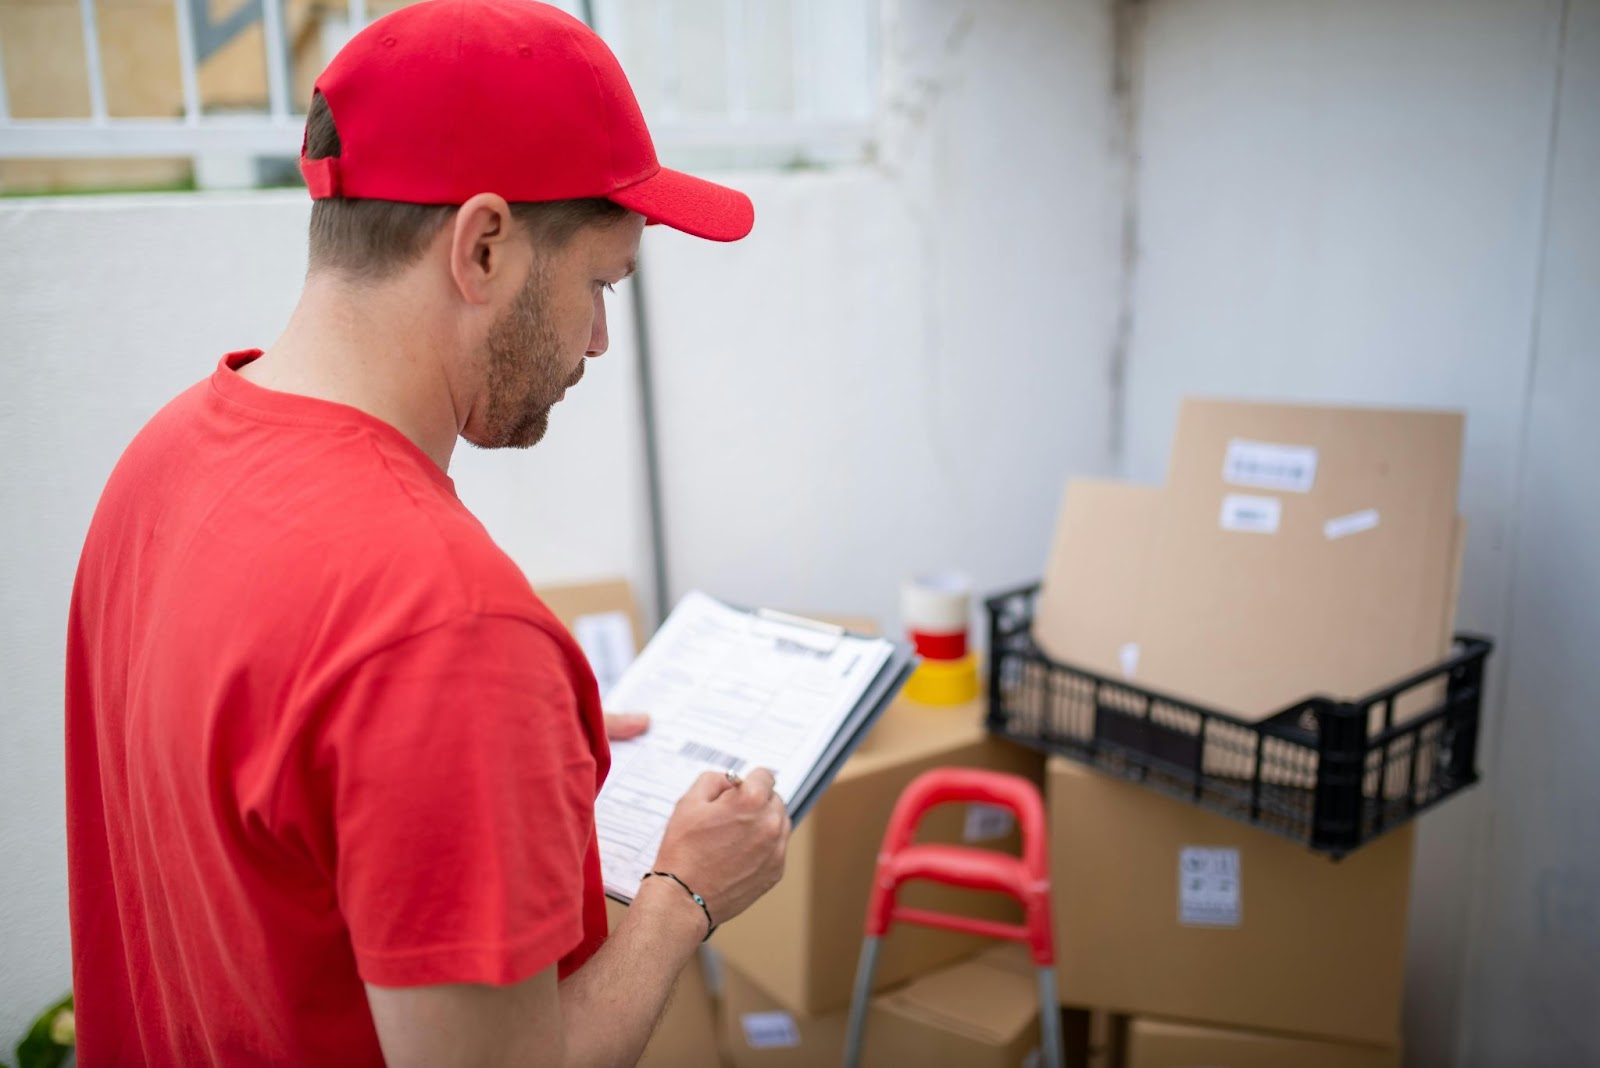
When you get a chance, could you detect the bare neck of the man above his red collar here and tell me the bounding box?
[240,275,461,472]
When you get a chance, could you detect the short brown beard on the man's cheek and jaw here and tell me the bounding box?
[467,265,584,449]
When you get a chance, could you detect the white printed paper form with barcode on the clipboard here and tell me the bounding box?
[595,592,893,900]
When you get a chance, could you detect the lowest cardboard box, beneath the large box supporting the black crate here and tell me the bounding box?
[1126,1018,1400,1068]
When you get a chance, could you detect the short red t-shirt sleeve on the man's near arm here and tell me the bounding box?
[322,616,595,986]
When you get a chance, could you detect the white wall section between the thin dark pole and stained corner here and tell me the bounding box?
[645,0,1117,625]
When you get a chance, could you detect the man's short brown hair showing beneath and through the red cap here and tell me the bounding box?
[306,93,627,281]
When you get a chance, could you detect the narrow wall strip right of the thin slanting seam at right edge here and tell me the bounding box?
[1462,0,1600,1066]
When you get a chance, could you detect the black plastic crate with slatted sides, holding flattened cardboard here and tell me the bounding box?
[987,584,1494,859]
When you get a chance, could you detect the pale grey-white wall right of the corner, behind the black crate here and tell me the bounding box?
[1125,0,1600,1066]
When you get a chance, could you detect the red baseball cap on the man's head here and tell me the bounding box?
[301,0,755,241]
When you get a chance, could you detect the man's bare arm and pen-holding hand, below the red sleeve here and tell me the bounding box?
[366,771,789,1068]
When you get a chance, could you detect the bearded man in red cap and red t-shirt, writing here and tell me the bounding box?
[67,0,789,1068]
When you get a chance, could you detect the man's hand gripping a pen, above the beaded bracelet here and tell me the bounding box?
[656,767,790,924]
